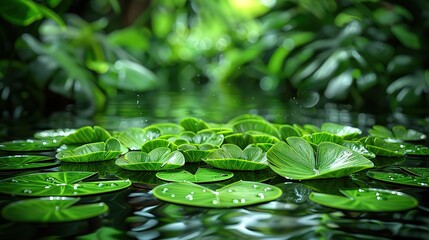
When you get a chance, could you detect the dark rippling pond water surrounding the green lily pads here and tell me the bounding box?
[0,89,429,239]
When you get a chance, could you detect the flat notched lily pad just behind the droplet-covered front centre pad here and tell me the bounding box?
[156,168,234,183]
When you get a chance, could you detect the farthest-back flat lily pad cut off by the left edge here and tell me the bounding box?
[0,139,61,152]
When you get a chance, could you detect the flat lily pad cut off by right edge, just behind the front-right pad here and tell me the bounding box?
[366,168,429,187]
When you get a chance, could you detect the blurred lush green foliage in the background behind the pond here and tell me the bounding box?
[0,0,429,118]
